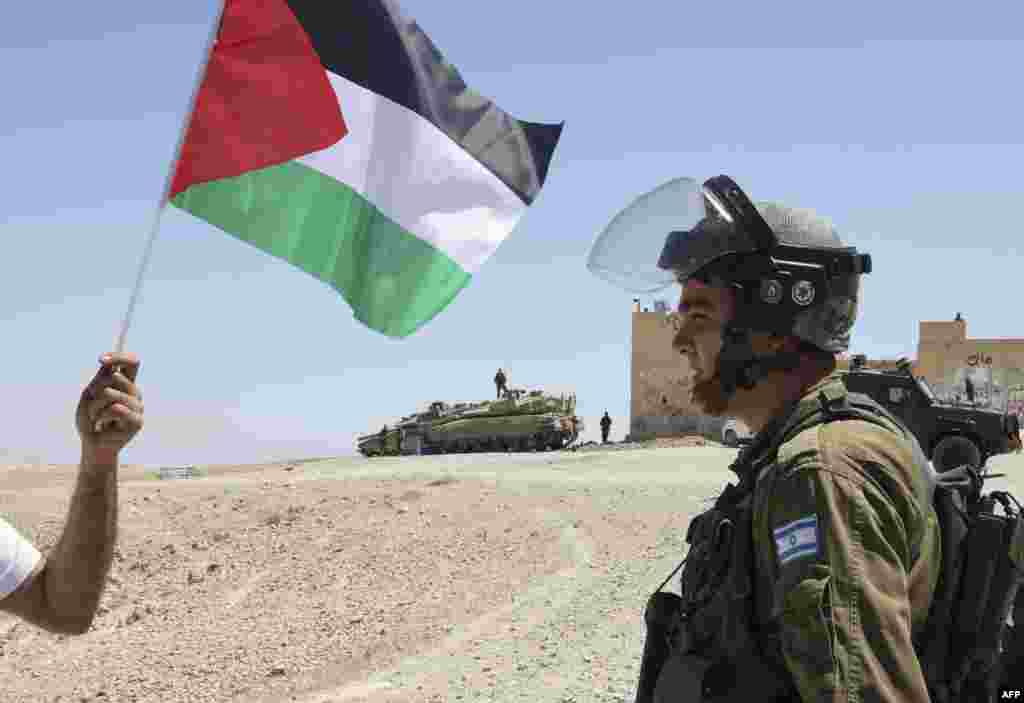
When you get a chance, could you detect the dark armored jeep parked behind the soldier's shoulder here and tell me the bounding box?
[843,356,1020,472]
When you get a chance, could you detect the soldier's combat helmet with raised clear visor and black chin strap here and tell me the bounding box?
[587,176,871,396]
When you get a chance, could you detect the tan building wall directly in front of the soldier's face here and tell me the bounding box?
[630,303,725,437]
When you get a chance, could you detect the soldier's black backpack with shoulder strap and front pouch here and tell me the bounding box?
[636,393,1024,703]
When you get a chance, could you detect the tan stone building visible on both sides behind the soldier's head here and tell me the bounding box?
[630,298,1024,439]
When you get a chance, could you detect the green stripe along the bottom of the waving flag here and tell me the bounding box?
[171,162,470,337]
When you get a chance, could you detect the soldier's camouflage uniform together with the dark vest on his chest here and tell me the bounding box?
[655,375,941,703]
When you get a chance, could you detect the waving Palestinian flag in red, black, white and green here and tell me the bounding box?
[170,0,562,337]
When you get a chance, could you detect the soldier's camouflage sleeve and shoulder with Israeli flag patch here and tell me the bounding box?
[753,375,941,703]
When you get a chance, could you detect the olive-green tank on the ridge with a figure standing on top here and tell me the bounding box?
[356,388,584,456]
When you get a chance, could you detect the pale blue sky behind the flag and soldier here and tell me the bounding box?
[0,0,1024,465]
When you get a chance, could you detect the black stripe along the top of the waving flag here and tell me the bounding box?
[288,0,563,205]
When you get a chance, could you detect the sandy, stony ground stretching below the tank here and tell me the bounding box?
[0,446,1024,703]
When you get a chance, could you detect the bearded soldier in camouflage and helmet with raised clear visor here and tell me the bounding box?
[591,176,940,703]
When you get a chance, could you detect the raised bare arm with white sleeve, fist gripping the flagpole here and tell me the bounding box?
[0,353,142,634]
